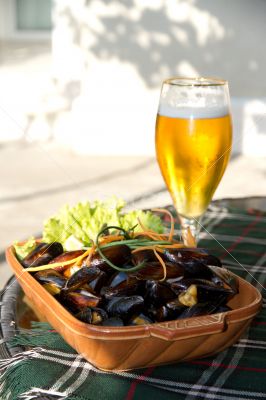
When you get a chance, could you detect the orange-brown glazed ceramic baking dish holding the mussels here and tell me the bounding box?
[6,246,262,371]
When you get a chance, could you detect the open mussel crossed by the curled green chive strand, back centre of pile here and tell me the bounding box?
[90,244,131,272]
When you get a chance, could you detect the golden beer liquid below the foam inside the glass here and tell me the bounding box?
[156,114,232,218]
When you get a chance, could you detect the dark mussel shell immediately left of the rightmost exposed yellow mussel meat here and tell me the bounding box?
[144,280,176,306]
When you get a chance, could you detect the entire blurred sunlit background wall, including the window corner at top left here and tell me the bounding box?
[0,0,266,156]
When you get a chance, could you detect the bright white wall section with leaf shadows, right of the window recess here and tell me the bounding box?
[47,0,266,155]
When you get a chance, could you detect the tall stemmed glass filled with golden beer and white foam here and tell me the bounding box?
[156,78,232,243]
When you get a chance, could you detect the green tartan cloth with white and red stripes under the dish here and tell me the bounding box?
[0,207,266,400]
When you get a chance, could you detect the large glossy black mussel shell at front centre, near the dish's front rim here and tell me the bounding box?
[106,296,144,321]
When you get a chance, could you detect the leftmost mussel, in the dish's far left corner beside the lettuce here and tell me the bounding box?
[21,242,63,268]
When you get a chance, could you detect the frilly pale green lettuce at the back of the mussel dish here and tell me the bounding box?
[43,197,164,250]
